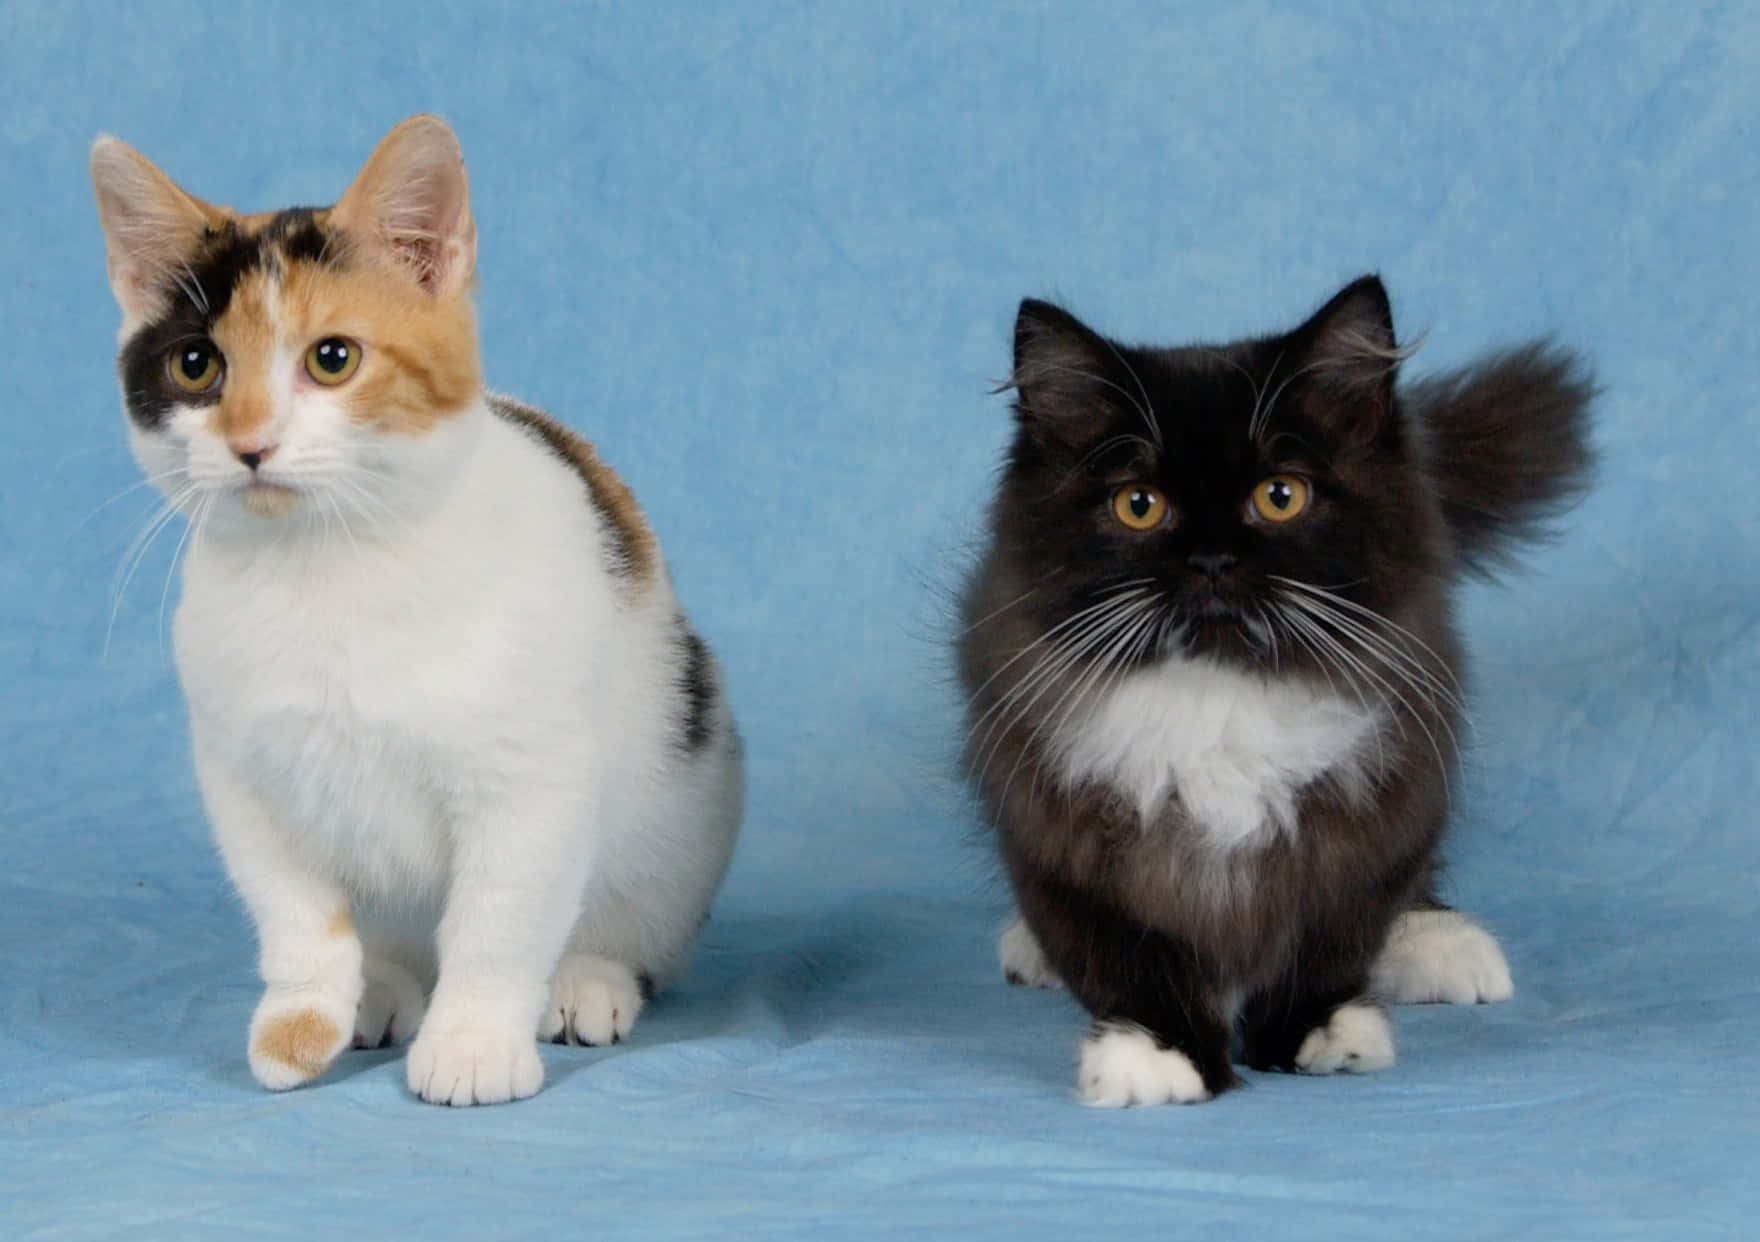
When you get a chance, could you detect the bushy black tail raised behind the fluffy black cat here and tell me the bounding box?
[1403,341,1595,574]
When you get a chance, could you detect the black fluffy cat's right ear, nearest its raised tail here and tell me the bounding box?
[1294,276,1408,442]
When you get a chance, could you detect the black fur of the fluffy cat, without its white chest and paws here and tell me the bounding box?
[957,276,1591,1094]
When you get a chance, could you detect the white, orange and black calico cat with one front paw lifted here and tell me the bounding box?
[92,116,743,1105]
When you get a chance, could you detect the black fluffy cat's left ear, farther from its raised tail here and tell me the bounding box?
[1008,297,1112,442]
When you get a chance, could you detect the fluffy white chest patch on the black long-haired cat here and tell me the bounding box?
[1051,660,1378,850]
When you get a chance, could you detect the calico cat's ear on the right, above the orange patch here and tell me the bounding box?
[331,116,477,296]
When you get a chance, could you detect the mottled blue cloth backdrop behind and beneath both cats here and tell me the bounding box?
[0,0,1760,1242]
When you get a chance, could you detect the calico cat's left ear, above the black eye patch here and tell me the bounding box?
[92,135,218,322]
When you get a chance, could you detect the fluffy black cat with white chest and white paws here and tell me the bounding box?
[957,276,1591,1105]
